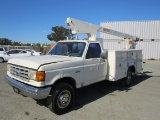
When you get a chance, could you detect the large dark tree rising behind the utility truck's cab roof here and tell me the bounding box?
[47,26,74,42]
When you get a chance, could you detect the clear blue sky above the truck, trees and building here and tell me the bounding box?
[0,0,160,43]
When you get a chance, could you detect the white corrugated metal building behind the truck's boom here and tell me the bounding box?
[100,20,160,59]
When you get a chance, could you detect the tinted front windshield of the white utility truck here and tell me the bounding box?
[48,42,86,57]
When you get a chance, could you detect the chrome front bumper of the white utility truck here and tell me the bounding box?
[5,76,51,99]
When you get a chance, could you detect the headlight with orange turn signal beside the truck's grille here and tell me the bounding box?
[28,70,45,82]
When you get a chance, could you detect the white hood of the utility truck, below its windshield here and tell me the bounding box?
[8,55,75,69]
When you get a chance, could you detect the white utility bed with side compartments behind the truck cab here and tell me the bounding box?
[106,49,142,81]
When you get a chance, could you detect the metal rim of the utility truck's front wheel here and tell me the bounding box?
[57,90,71,108]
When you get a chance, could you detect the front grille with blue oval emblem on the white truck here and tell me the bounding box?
[10,65,29,81]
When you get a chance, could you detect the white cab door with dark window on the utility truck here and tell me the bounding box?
[84,43,107,85]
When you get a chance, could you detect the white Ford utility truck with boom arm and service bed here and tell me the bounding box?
[5,18,142,114]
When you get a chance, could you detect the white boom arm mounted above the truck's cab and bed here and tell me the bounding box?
[66,18,138,48]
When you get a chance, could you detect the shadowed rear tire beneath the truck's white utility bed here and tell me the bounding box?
[120,68,133,86]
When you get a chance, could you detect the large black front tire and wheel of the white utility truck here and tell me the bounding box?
[47,83,75,115]
